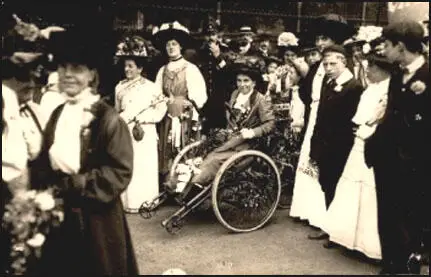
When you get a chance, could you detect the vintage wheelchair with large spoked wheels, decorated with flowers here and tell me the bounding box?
[139,90,297,234]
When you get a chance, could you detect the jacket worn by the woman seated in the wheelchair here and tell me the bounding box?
[215,90,275,152]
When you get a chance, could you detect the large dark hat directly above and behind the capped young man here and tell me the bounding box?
[314,13,355,44]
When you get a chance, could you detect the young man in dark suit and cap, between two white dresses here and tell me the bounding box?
[310,45,363,247]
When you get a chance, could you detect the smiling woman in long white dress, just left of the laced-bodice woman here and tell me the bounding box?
[115,56,166,213]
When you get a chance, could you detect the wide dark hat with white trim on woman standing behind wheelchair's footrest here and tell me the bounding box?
[153,21,193,51]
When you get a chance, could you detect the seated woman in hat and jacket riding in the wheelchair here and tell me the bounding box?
[168,59,275,199]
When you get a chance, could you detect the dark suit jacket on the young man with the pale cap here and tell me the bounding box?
[310,70,363,164]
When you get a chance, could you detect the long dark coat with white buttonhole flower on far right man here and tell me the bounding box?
[365,58,431,271]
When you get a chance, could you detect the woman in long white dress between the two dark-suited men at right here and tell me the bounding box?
[325,50,393,259]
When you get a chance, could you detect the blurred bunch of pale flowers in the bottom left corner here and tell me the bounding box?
[3,189,64,274]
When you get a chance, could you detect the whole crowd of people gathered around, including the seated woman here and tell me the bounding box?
[0,8,431,275]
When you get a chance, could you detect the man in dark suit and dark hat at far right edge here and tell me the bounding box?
[365,21,431,274]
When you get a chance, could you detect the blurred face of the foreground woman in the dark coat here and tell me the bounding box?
[58,63,95,97]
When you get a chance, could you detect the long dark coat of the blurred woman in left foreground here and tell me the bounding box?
[32,101,138,276]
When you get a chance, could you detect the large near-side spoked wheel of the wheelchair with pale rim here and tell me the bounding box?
[212,150,281,233]
